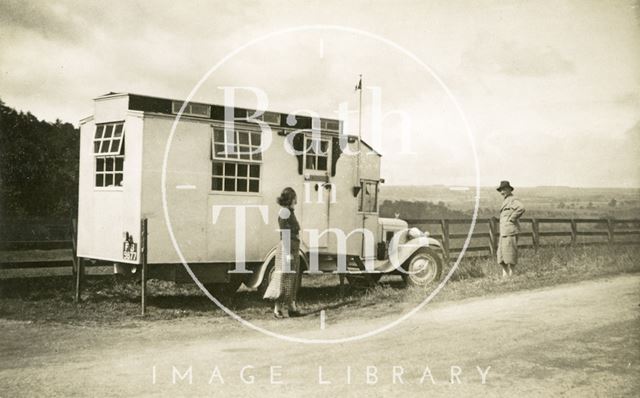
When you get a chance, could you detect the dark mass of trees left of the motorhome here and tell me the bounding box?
[0,101,80,219]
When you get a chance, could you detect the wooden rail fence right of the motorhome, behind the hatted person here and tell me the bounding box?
[406,217,640,260]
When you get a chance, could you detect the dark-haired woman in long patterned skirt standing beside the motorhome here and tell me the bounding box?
[264,187,300,318]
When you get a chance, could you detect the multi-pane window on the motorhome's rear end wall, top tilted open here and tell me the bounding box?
[93,122,124,188]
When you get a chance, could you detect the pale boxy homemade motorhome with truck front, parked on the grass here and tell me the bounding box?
[77,93,441,291]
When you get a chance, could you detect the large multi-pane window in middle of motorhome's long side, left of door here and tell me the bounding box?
[211,128,262,192]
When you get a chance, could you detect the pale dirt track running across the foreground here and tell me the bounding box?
[0,275,640,397]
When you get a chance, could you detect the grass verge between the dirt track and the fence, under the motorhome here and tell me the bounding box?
[0,245,640,326]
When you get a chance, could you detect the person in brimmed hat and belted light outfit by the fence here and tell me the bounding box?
[497,181,524,278]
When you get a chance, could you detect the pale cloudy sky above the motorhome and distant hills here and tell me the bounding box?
[0,0,640,187]
